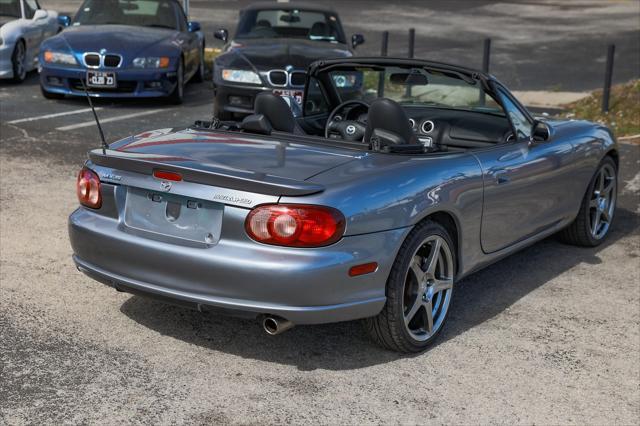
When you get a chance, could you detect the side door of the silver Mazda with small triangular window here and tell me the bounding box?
[475,86,573,253]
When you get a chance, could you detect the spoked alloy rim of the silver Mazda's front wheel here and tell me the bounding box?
[589,164,617,240]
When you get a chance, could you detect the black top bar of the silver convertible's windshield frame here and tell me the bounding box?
[309,56,496,81]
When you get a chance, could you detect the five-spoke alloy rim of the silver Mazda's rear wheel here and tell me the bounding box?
[403,235,454,341]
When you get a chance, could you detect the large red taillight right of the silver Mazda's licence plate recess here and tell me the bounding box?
[245,204,345,247]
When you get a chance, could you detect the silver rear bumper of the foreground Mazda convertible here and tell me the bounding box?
[69,206,408,324]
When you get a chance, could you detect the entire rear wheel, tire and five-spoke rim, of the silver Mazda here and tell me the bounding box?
[365,221,456,353]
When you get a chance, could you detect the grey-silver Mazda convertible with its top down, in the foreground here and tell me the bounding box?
[69,58,618,352]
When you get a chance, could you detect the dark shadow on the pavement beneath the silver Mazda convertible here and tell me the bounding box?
[120,209,640,370]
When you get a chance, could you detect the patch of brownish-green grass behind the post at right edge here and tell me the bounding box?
[561,80,640,137]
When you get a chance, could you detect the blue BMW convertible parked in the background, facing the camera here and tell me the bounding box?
[40,0,205,103]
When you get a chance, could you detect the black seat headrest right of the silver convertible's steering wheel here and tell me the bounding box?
[364,98,415,144]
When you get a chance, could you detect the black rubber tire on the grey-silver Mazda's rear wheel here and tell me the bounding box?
[364,221,456,353]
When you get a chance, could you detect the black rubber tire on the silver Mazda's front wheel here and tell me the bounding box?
[558,156,618,247]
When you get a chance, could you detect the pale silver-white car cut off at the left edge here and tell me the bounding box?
[0,0,61,82]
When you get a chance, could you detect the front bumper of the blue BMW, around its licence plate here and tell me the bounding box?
[40,66,176,98]
